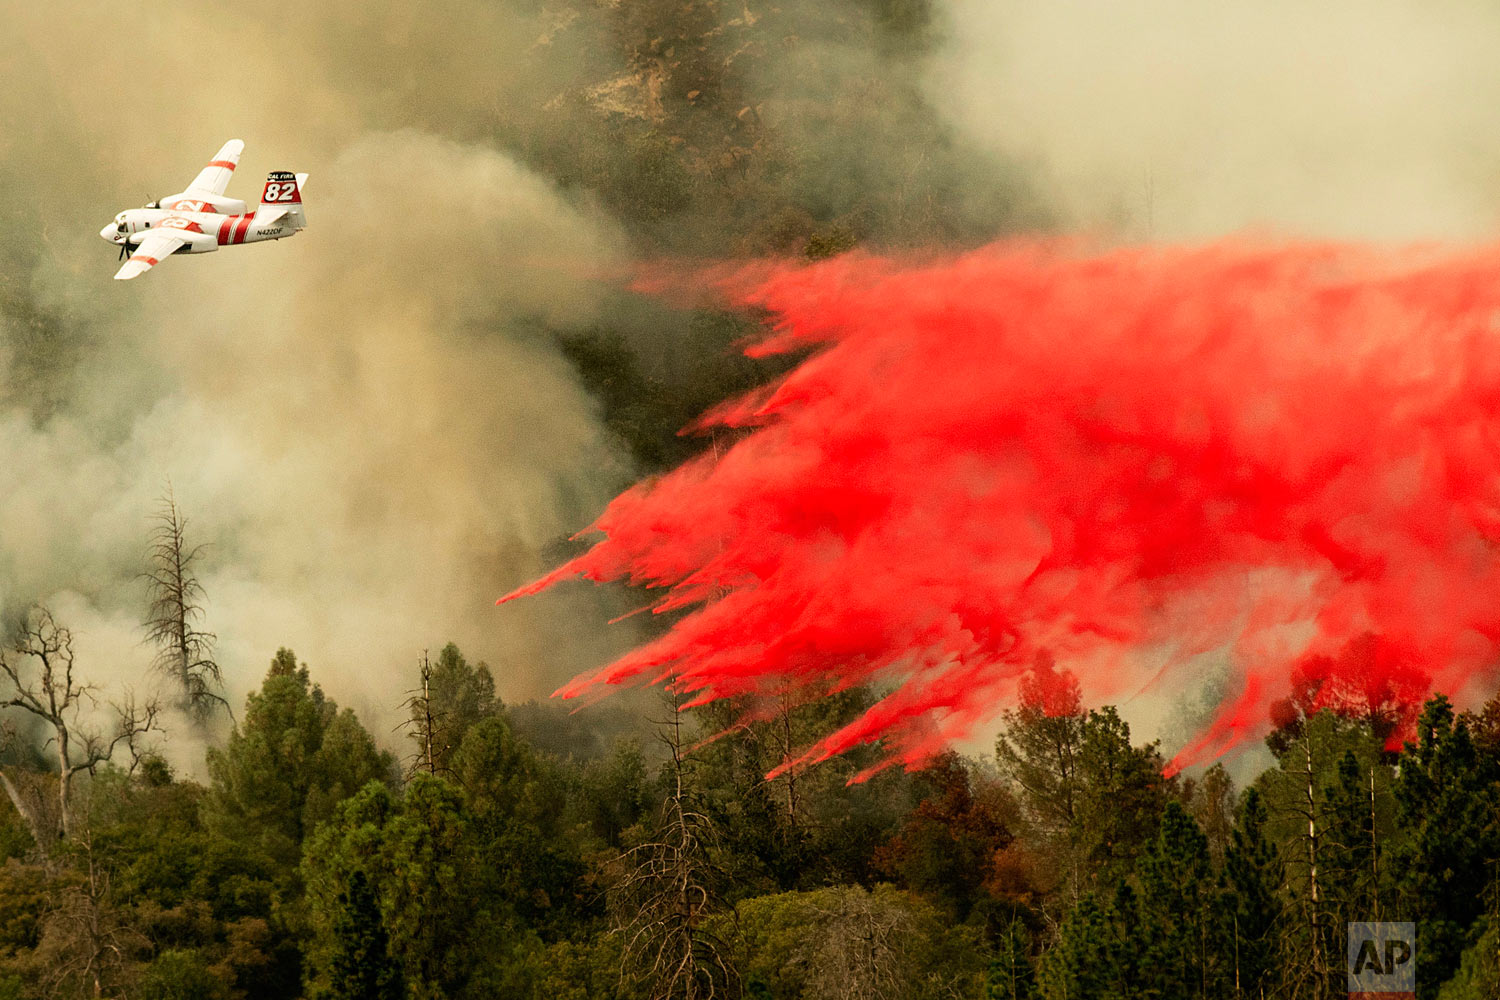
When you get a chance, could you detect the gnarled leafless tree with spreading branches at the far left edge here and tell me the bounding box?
[0,607,159,847]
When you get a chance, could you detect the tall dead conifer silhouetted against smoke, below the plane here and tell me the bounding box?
[146,484,230,723]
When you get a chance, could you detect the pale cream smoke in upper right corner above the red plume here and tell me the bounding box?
[930,0,1500,240]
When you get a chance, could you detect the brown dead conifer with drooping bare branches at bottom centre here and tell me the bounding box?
[611,694,740,1000]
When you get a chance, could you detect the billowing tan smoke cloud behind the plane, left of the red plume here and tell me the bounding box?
[0,3,639,763]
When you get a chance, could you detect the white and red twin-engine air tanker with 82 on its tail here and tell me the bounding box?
[99,139,308,280]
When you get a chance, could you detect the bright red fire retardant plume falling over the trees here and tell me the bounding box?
[510,243,1500,766]
